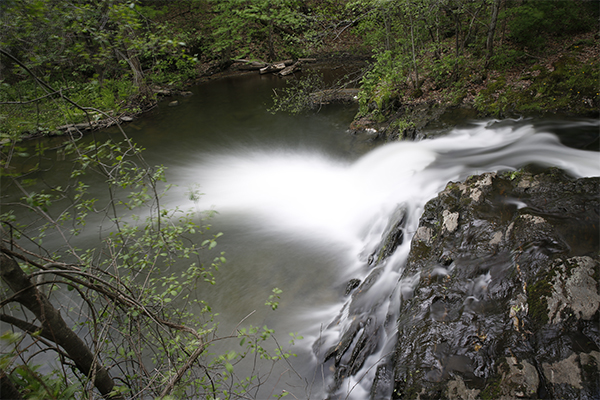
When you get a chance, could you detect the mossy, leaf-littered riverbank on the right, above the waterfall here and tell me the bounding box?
[350,33,600,140]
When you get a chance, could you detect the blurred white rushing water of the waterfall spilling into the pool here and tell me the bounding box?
[176,121,600,399]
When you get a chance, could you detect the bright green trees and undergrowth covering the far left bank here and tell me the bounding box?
[0,0,198,140]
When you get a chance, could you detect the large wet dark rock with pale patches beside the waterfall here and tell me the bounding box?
[392,169,600,399]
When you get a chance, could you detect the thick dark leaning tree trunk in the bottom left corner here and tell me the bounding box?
[0,254,124,400]
